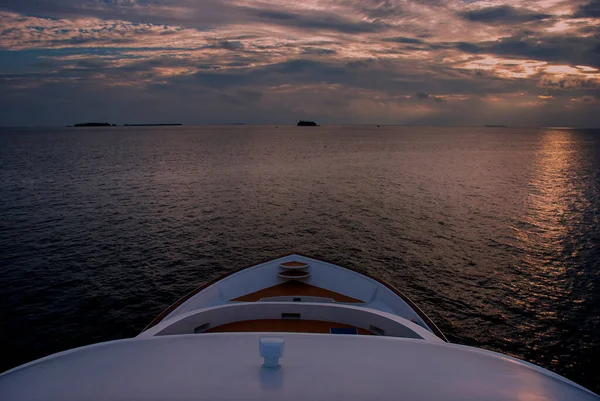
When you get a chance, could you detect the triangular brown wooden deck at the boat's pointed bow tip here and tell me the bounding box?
[232,280,364,303]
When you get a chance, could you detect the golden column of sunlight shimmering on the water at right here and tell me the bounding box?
[506,130,590,365]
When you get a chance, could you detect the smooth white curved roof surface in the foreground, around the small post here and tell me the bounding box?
[0,333,600,401]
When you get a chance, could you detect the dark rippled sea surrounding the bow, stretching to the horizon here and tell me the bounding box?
[0,126,600,391]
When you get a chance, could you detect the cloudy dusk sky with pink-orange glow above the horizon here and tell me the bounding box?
[0,0,600,127]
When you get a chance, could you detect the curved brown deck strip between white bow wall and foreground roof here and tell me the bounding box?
[203,319,373,335]
